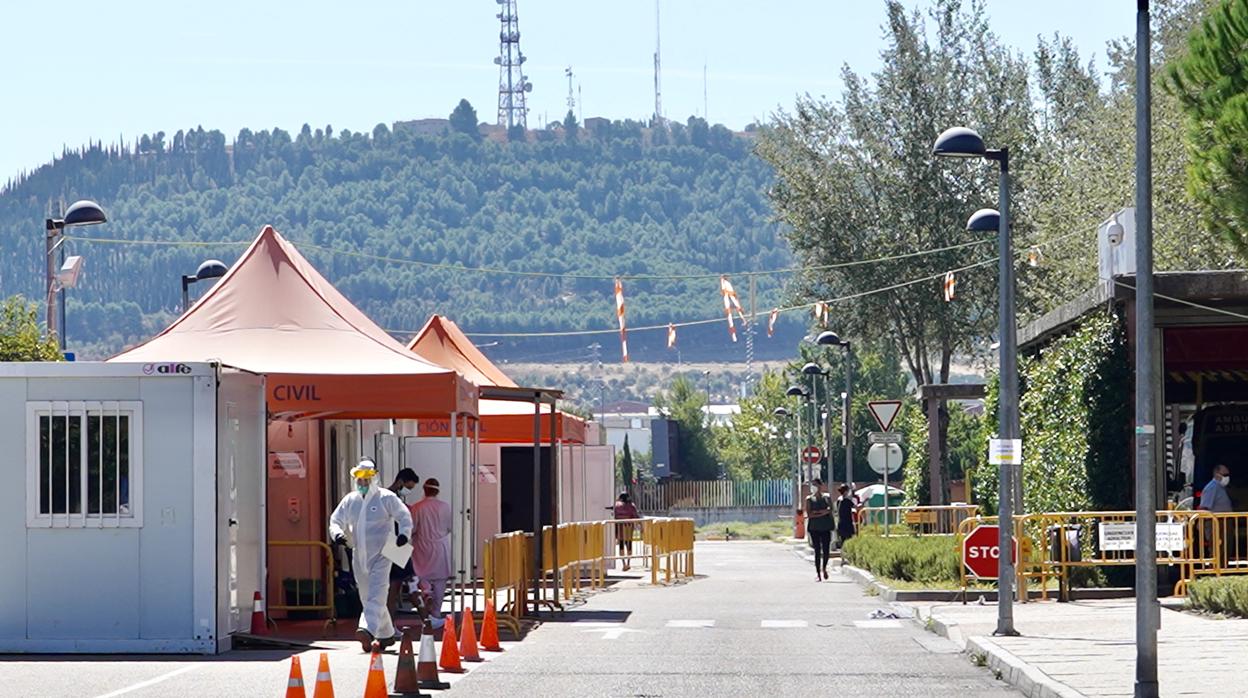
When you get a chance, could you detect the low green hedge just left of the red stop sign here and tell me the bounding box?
[841,528,962,582]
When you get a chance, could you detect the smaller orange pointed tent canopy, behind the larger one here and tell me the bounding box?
[407,315,585,443]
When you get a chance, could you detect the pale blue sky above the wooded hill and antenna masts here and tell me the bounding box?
[0,0,1134,180]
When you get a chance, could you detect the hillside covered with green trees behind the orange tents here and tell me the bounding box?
[0,108,805,361]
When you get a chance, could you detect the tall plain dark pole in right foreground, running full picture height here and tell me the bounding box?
[1136,0,1161,698]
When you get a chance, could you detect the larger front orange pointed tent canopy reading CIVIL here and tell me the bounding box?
[109,226,477,418]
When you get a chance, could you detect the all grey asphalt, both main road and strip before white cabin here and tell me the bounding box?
[0,542,1016,698]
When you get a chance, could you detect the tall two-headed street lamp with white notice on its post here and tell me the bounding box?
[932,126,1022,636]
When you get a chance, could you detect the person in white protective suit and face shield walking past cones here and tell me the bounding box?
[329,460,412,652]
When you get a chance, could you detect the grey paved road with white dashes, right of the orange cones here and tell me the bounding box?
[448,542,1015,698]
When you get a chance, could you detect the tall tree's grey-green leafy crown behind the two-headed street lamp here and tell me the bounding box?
[759,0,1035,496]
